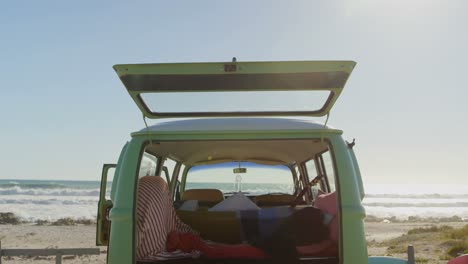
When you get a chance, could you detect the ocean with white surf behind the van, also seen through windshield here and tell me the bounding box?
[0,180,468,222]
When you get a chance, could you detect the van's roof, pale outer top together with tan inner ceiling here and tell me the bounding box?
[132,118,342,166]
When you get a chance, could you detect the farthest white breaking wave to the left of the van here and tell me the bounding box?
[0,186,100,196]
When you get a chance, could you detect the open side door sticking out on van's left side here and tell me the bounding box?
[96,164,117,246]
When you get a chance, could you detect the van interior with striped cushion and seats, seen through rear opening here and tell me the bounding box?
[135,138,339,263]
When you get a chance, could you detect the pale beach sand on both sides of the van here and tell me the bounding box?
[0,222,466,264]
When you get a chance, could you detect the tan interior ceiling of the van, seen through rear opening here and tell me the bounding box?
[147,139,328,165]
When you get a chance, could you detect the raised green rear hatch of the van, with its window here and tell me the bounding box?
[114,61,356,118]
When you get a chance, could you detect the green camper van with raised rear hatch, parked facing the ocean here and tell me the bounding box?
[96,60,413,264]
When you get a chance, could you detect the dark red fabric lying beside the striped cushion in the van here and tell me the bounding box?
[166,232,266,259]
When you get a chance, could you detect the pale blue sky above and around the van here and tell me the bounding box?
[0,0,468,184]
